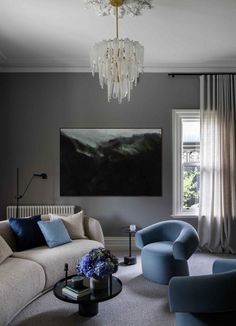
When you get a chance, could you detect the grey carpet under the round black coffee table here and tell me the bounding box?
[9,253,235,326]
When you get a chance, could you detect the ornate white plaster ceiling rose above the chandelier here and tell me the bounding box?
[84,0,153,18]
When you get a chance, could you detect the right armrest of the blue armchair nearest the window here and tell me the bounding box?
[173,227,199,260]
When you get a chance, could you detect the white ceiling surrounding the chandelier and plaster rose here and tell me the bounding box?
[0,0,236,72]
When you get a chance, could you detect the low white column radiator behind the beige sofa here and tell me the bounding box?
[7,205,75,218]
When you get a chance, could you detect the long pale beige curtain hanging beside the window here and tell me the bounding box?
[198,75,236,253]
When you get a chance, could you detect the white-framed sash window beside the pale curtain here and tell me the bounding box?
[172,110,200,216]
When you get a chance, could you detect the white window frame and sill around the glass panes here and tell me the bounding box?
[172,109,201,217]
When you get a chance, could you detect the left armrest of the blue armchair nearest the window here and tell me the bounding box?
[135,223,162,249]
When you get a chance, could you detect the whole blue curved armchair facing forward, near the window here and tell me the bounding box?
[135,220,199,284]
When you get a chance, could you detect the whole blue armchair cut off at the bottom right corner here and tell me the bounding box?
[169,259,236,326]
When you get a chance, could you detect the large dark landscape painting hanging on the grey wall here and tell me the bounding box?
[60,129,162,196]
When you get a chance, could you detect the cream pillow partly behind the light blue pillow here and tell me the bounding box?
[49,211,87,240]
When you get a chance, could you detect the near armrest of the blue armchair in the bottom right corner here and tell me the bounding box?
[169,271,236,313]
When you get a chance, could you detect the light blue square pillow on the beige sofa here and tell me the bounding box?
[38,219,72,248]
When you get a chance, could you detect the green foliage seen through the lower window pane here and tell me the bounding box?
[183,167,200,208]
